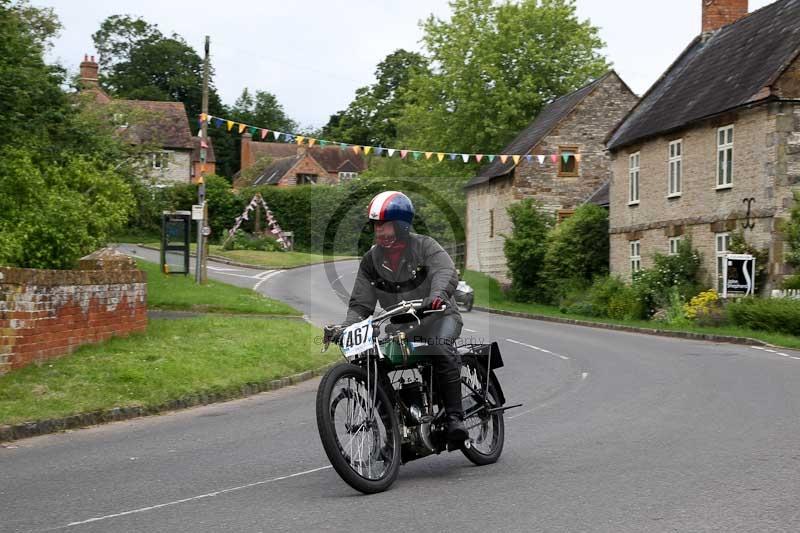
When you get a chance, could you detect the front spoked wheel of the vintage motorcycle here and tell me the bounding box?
[317,363,400,494]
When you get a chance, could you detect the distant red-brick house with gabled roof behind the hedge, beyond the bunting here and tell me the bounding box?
[234,133,367,187]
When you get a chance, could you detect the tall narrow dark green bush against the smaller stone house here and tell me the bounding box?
[503,198,553,301]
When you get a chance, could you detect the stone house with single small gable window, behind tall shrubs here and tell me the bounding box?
[465,70,637,283]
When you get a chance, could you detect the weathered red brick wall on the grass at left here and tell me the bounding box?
[0,251,147,374]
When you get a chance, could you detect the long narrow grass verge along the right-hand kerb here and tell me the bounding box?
[464,270,800,350]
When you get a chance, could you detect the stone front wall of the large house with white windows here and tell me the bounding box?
[610,103,800,288]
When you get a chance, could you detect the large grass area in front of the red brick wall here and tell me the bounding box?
[0,316,337,425]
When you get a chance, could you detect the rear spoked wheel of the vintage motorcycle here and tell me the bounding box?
[461,355,505,465]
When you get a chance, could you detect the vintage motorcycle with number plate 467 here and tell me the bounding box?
[316,300,521,494]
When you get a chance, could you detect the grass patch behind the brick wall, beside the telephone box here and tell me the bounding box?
[136,260,302,316]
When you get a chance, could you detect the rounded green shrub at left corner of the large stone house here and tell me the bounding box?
[543,204,609,302]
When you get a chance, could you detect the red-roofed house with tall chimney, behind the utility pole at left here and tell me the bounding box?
[79,56,215,186]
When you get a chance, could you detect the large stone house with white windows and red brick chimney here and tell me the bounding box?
[608,0,800,289]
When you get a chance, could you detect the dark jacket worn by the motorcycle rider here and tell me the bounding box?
[344,233,461,325]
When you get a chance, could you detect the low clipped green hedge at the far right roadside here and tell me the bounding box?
[726,298,800,335]
